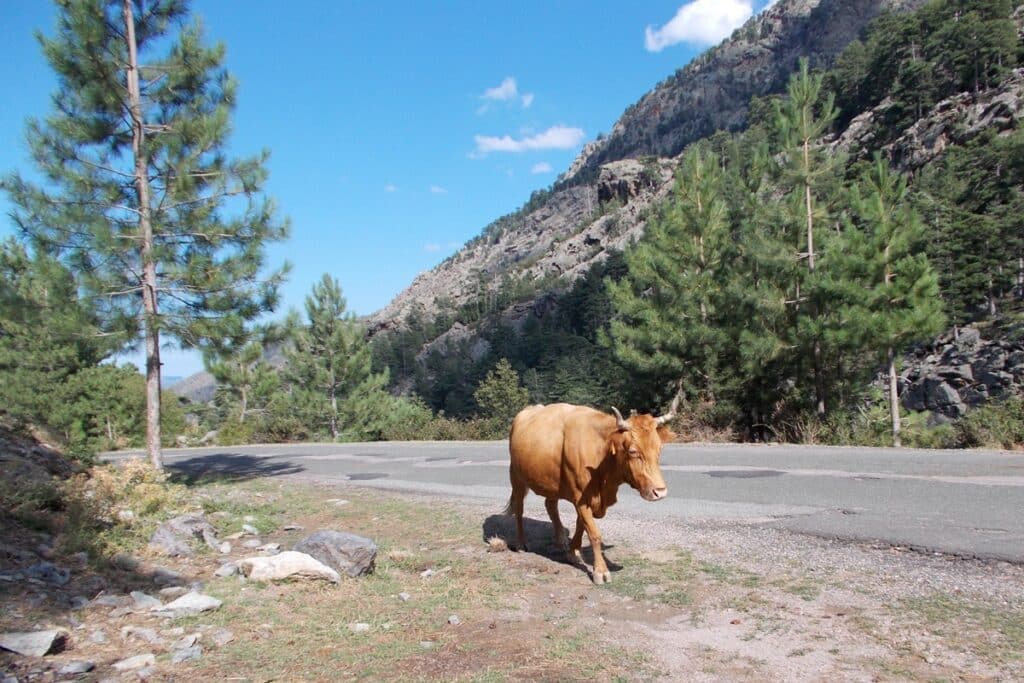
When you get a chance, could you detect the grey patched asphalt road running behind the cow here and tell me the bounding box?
[110,441,1024,563]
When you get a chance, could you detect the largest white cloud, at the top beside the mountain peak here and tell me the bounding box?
[644,0,754,52]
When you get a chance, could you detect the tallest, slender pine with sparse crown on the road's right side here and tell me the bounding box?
[775,58,838,417]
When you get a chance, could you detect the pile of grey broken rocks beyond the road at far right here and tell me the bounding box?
[900,328,1024,418]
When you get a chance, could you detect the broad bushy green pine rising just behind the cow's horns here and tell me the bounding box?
[607,147,732,398]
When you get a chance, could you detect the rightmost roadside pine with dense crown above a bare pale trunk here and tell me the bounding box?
[844,154,945,447]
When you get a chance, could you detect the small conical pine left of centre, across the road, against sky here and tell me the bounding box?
[285,274,391,440]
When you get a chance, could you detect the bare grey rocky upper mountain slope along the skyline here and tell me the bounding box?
[370,0,924,333]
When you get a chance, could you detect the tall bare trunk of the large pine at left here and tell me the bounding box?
[122,0,164,469]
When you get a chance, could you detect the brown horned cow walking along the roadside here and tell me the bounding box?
[506,395,679,584]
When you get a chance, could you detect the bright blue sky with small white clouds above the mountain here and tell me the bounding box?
[0,0,768,375]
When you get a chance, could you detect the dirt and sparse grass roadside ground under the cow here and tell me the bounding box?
[0,477,1024,681]
